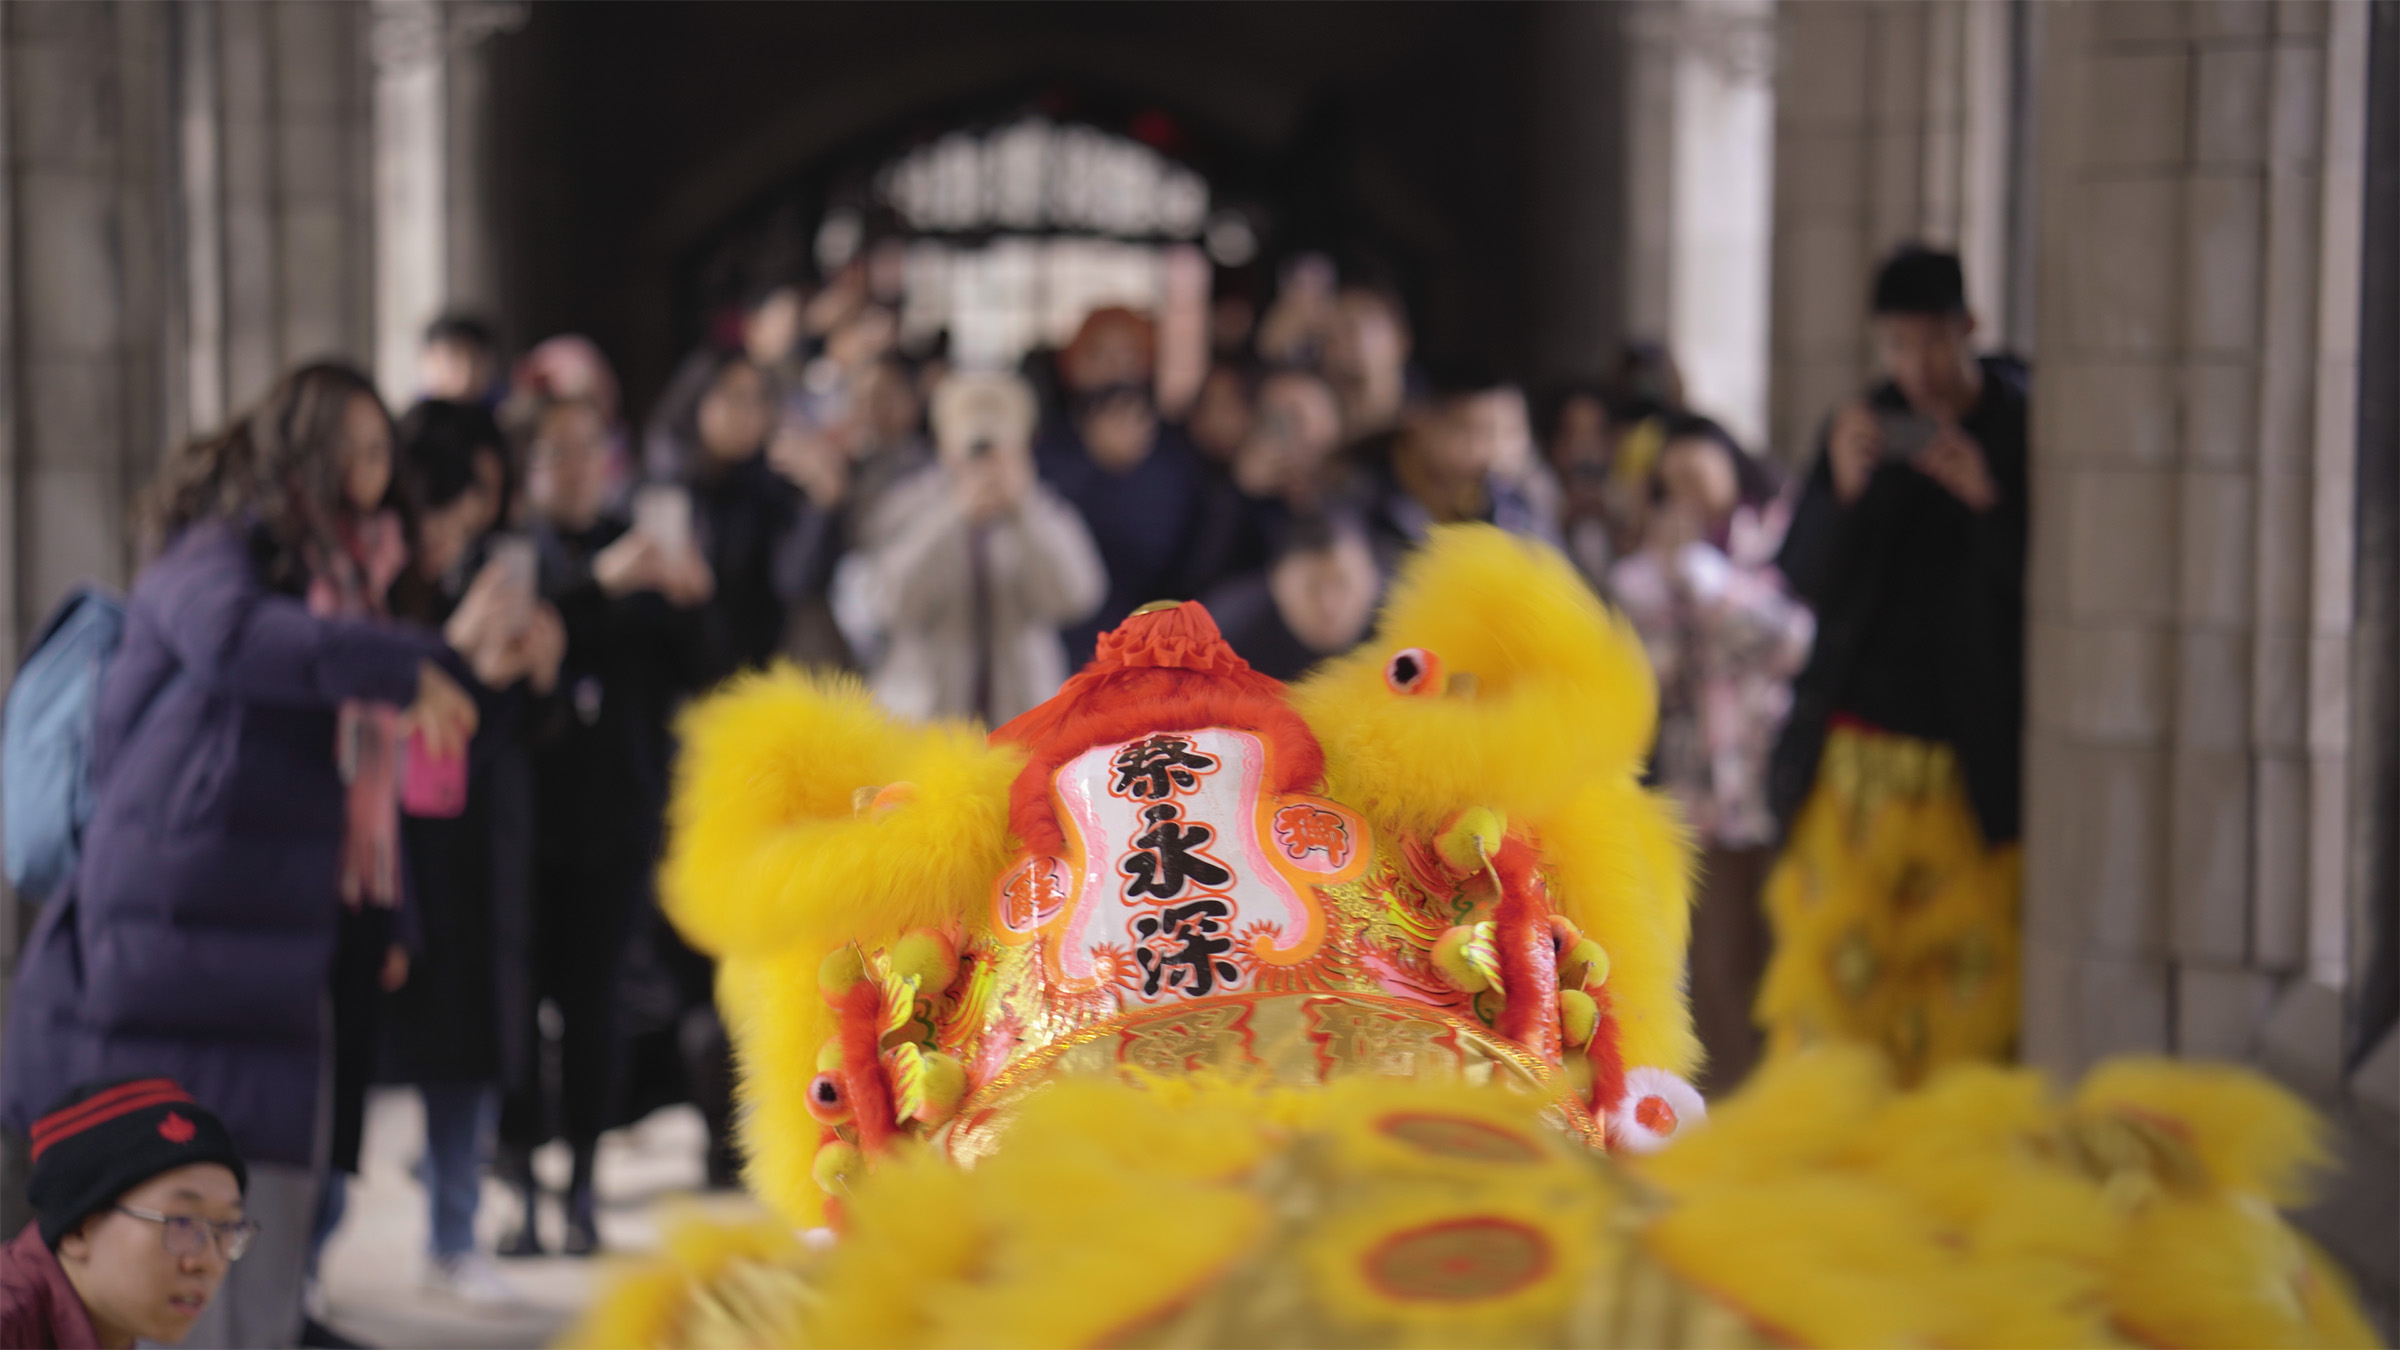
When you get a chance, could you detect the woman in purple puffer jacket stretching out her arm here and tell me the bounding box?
[0,365,475,1345]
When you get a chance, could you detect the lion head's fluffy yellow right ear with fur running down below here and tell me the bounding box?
[1291,526,1699,1076]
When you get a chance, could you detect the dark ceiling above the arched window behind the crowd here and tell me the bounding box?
[487,2,1618,408]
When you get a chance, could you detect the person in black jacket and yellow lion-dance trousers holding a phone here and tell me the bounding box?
[1759,245,2028,1081]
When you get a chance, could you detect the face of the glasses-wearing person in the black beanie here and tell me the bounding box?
[58,1163,242,1345]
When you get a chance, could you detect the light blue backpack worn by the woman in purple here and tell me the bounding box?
[0,586,125,903]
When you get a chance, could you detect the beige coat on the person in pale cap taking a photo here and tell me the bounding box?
[835,466,1109,725]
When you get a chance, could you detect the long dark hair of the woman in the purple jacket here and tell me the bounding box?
[144,360,391,591]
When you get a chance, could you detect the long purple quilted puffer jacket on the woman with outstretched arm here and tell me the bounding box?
[0,521,449,1165]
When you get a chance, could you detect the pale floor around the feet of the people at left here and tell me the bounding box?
[324,1088,751,1348]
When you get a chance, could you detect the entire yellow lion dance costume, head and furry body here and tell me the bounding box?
[574,526,2374,1345]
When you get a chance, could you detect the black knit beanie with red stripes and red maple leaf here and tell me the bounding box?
[24,1079,250,1252]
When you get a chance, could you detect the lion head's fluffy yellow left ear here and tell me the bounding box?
[660,668,1022,956]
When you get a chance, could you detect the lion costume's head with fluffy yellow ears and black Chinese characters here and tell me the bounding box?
[665,531,1704,1220]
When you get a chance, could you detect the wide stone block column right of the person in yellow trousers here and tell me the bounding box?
[2026,0,2366,1088]
